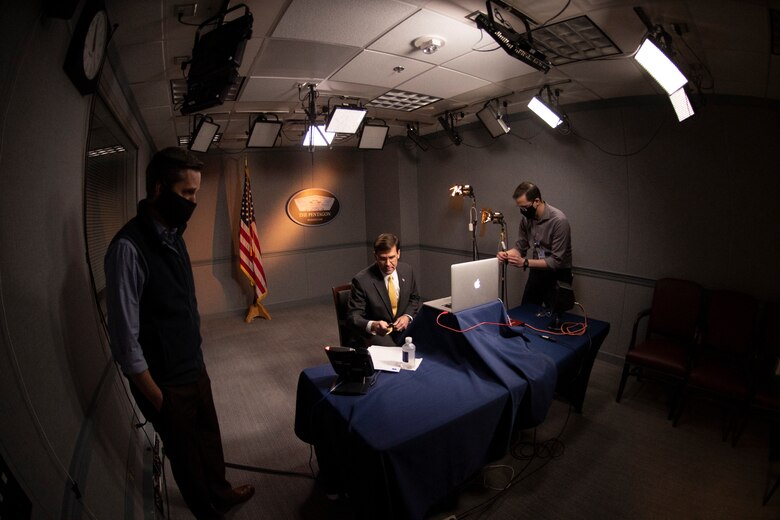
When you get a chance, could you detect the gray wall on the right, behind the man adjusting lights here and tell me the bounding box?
[418,96,780,361]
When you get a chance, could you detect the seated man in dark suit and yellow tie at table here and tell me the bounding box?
[347,233,420,346]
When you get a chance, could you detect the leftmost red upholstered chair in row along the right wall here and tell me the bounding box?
[615,278,703,418]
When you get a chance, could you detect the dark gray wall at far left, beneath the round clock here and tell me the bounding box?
[0,2,148,519]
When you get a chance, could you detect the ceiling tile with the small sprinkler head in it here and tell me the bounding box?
[331,51,433,88]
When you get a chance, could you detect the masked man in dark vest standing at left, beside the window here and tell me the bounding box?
[105,147,255,520]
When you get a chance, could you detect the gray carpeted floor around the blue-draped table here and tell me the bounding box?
[158,300,780,520]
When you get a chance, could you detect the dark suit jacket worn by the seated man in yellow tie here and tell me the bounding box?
[347,262,420,345]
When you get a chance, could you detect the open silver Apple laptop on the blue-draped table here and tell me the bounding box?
[423,258,499,312]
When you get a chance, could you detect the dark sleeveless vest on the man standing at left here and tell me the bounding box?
[114,201,204,385]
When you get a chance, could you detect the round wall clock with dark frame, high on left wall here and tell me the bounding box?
[63,0,111,95]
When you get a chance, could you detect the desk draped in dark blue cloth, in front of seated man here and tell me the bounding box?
[295,302,608,519]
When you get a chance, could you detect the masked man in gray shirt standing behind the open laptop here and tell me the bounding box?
[497,182,572,306]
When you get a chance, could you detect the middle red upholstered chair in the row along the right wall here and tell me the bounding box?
[674,291,759,440]
